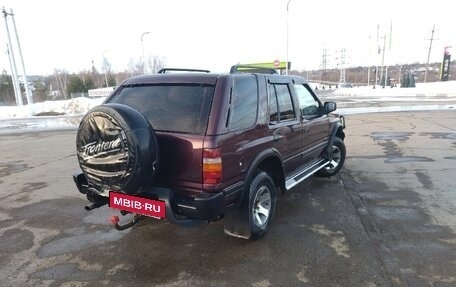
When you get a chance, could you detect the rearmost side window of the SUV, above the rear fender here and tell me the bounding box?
[228,75,258,130]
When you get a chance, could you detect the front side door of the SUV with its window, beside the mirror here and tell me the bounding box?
[293,81,329,164]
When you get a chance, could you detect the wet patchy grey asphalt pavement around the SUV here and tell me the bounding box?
[0,111,456,287]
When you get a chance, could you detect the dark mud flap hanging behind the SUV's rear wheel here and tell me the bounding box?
[223,206,252,239]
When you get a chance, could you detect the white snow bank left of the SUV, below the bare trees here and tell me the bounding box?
[0,97,105,119]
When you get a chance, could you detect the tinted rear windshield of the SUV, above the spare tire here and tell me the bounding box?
[109,84,214,135]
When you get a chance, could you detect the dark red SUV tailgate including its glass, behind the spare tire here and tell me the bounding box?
[110,82,214,190]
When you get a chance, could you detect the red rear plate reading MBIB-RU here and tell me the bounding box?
[109,191,166,218]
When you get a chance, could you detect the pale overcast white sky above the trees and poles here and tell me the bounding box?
[0,0,456,75]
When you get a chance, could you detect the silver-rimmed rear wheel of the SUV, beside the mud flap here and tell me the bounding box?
[248,172,276,240]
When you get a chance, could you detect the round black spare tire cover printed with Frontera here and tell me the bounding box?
[76,104,158,194]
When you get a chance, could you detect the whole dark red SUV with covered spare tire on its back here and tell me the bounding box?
[74,66,345,239]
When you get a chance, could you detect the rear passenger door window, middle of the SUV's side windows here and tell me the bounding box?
[269,84,296,122]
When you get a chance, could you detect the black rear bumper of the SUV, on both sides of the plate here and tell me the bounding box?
[73,173,243,226]
